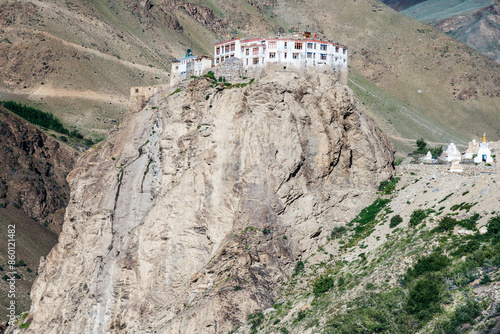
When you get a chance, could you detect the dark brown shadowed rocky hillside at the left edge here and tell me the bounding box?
[0,107,78,233]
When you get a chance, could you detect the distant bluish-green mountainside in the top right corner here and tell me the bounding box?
[382,0,500,63]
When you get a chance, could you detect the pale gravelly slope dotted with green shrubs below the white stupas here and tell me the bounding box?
[235,159,500,334]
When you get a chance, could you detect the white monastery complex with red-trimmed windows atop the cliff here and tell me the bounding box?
[170,32,347,86]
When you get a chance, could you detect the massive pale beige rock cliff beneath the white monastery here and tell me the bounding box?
[25,74,393,333]
